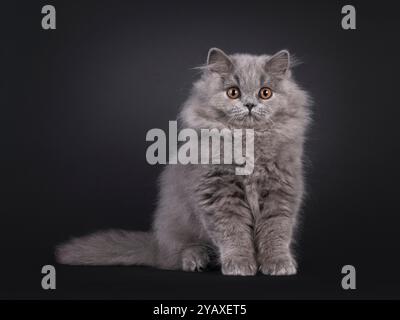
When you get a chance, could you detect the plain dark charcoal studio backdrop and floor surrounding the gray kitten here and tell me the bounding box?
[0,0,400,299]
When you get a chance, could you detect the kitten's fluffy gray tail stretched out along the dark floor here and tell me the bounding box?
[56,230,158,266]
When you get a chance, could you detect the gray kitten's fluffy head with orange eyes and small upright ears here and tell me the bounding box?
[181,48,307,130]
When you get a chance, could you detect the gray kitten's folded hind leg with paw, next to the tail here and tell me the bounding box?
[153,165,217,271]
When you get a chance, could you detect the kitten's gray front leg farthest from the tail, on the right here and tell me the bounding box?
[255,178,301,275]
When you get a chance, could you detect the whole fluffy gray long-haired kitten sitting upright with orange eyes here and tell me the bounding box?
[56,48,310,276]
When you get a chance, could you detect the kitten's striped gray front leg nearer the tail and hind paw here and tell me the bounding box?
[198,174,257,276]
